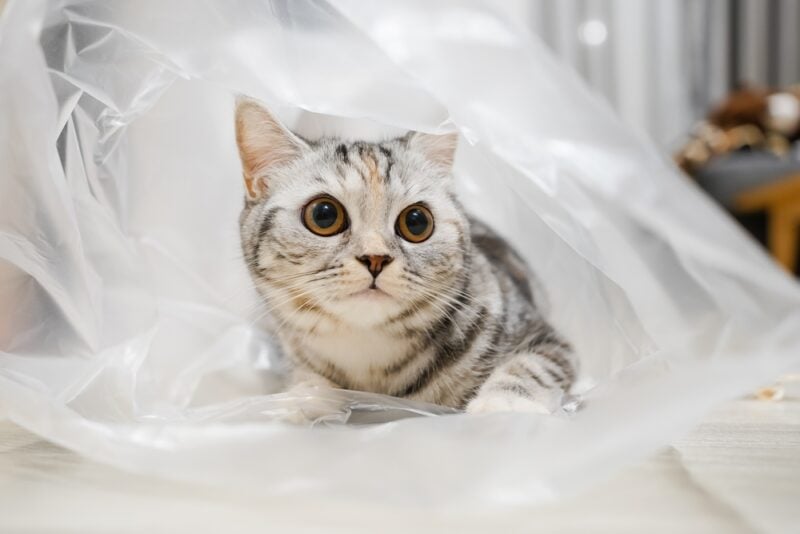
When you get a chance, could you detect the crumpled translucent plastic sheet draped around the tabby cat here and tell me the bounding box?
[0,0,800,513]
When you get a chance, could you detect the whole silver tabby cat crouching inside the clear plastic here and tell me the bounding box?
[236,99,576,413]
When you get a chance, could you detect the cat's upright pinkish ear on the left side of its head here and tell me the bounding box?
[236,97,308,200]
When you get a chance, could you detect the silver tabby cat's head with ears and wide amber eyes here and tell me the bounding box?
[236,101,469,328]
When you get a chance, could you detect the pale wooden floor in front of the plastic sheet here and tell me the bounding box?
[0,394,800,534]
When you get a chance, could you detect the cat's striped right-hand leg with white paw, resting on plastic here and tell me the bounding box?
[466,348,575,414]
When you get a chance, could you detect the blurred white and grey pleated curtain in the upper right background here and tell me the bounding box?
[519,0,800,149]
